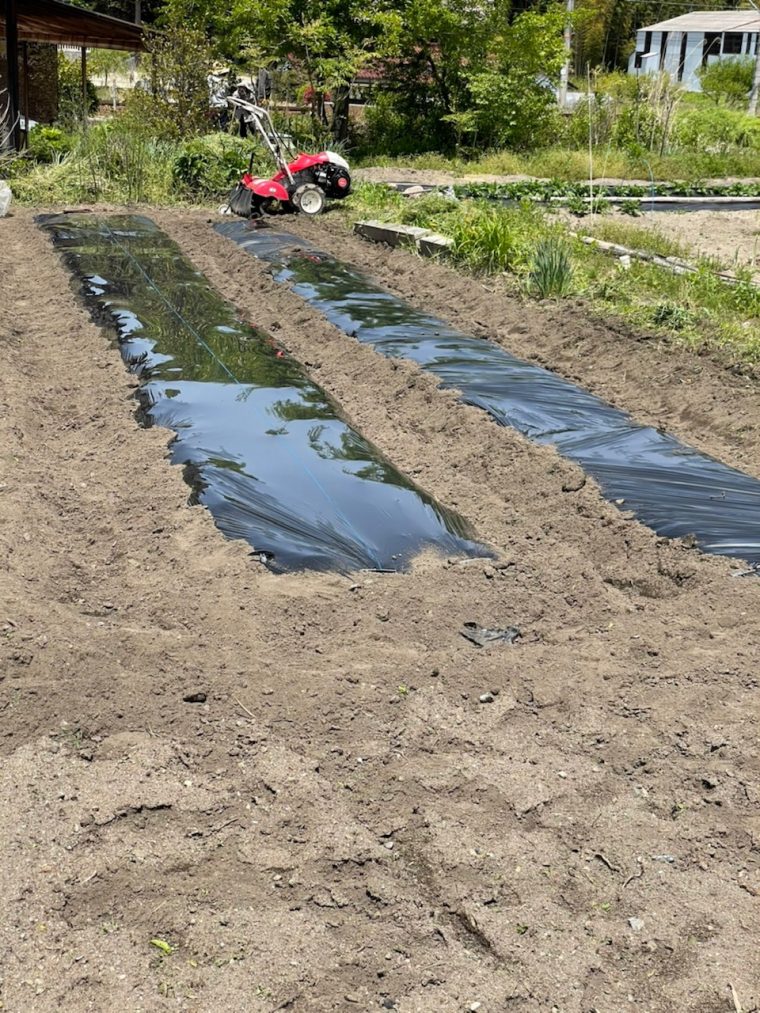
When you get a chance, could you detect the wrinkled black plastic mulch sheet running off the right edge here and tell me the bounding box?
[216,222,760,564]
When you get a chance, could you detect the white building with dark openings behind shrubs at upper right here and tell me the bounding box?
[628,10,760,91]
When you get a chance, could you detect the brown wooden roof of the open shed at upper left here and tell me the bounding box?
[0,0,144,53]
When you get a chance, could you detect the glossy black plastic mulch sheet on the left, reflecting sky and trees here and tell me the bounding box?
[40,214,488,570]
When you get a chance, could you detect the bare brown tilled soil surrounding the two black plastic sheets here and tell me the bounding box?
[0,212,760,1013]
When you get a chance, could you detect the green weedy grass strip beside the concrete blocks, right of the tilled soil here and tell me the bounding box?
[345,184,760,365]
